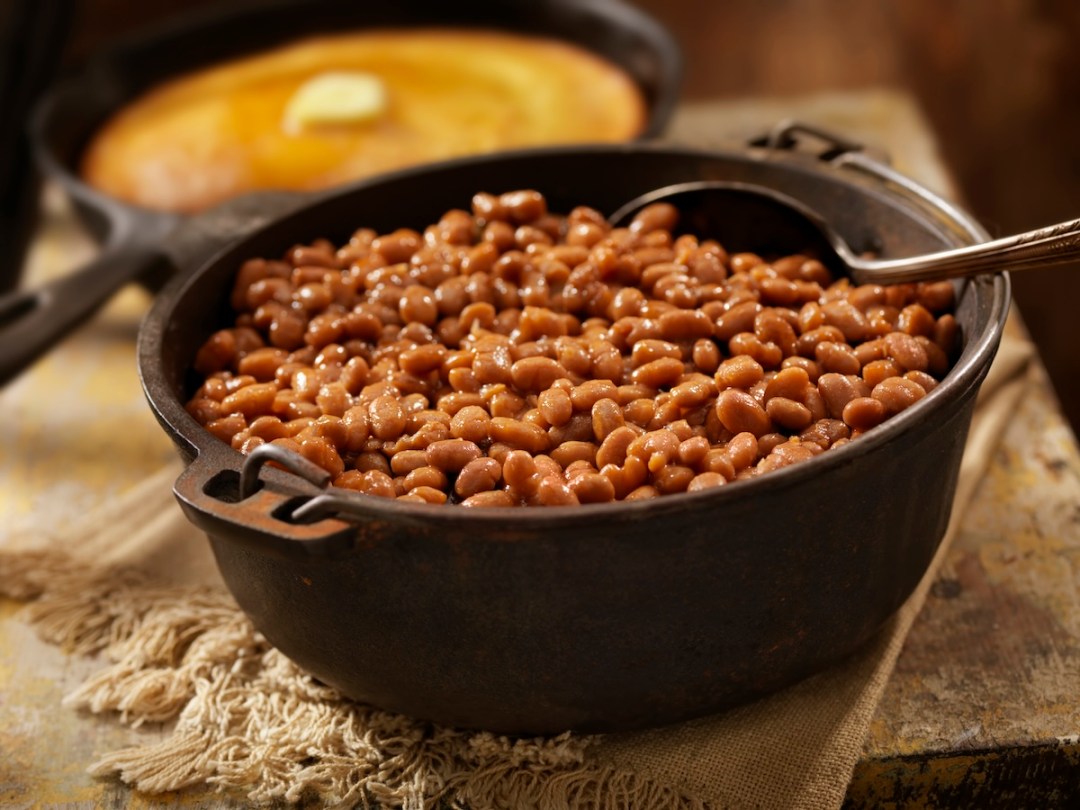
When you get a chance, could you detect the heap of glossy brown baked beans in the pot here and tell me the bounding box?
[188,190,959,507]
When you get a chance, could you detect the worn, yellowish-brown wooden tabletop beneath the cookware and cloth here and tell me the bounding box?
[0,92,1080,808]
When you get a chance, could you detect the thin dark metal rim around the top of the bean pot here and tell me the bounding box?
[138,143,1010,529]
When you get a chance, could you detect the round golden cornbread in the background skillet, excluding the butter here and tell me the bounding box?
[81,29,646,213]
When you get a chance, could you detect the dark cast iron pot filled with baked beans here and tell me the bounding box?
[138,138,1009,733]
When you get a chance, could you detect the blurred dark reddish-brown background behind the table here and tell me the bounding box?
[0,0,1080,429]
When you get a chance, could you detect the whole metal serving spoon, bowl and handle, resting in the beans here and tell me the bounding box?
[609,180,1080,284]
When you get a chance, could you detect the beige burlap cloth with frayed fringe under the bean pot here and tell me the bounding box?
[0,93,1031,810]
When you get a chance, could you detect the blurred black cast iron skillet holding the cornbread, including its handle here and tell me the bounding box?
[0,0,681,384]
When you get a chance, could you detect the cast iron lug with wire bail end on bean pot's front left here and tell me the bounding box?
[173,444,356,558]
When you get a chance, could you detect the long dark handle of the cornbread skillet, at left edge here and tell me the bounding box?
[0,242,165,386]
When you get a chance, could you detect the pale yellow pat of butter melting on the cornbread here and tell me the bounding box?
[283,71,387,132]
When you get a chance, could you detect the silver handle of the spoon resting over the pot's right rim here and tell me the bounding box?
[851,219,1080,284]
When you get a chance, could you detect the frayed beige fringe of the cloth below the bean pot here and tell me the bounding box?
[0,550,705,810]
